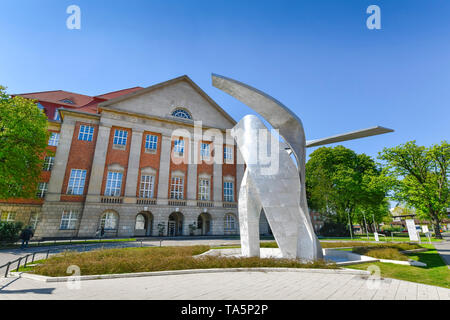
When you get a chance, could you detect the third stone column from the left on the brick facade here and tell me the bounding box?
[123,129,143,203]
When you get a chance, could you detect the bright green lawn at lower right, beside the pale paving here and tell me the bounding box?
[347,245,450,288]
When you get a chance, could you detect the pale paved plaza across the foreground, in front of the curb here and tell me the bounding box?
[0,272,450,300]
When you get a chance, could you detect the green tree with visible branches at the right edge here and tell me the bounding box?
[379,141,450,238]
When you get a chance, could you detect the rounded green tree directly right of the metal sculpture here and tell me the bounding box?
[306,146,389,236]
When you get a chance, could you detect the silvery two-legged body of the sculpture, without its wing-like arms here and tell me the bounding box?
[232,115,322,260]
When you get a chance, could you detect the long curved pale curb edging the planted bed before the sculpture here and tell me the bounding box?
[10,268,370,282]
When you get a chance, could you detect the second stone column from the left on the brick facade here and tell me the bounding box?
[86,124,111,202]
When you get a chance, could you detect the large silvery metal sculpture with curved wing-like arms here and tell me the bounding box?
[212,74,393,260]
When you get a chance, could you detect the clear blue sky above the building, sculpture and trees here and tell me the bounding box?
[0,0,450,160]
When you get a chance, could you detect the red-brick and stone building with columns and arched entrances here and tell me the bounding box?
[0,76,269,238]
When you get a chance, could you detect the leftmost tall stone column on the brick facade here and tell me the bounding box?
[45,118,75,201]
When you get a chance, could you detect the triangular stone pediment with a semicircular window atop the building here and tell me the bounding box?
[99,76,236,129]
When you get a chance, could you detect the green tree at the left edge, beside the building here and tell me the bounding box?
[0,86,49,199]
